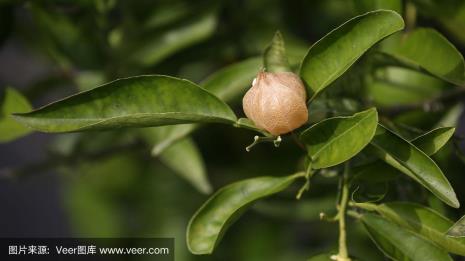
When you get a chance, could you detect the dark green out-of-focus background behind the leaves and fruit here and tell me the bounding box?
[0,0,465,260]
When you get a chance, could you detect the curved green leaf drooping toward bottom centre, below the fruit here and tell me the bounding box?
[187,173,304,255]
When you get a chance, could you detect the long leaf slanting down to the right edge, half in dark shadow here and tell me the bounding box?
[368,125,460,208]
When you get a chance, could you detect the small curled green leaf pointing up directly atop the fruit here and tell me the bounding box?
[263,31,292,72]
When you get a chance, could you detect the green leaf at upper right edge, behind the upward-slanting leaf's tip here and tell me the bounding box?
[382,28,465,85]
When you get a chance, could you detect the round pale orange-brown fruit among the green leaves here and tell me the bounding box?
[242,72,308,136]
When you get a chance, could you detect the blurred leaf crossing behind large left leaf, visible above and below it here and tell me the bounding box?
[148,57,262,154]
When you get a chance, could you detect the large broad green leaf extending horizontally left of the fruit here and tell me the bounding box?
[15,75,236,132]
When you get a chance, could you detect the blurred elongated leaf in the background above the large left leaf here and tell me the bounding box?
[130,12,217,66]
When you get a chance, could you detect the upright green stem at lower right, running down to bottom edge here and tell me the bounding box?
[337,163,350,261]
